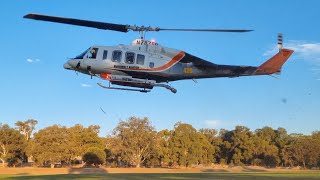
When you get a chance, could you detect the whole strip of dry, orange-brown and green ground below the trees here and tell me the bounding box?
[0,167,320,180]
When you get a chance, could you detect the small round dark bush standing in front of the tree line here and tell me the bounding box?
[82,147,106,167]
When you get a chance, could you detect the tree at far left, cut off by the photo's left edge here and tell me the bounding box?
[0,124,27,167]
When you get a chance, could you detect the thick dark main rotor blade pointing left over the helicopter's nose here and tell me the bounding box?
[24,14,128,32]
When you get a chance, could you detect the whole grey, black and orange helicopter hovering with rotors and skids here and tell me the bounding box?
[24,14,294,93]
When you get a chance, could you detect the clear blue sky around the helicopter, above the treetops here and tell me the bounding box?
[0,0,320,136]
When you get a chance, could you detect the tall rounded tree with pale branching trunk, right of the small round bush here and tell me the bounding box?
[107,117,157,167]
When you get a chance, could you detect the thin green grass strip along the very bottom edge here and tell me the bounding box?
[0,172,320,180]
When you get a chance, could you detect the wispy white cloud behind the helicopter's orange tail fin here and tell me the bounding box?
[263,41,320,66]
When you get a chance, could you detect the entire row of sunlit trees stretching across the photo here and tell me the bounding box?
[0,117,320,168]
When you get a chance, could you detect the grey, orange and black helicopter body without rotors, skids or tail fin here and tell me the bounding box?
[64,39,257,83]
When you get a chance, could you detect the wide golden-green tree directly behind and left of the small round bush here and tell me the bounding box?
[28,124,105,167]
